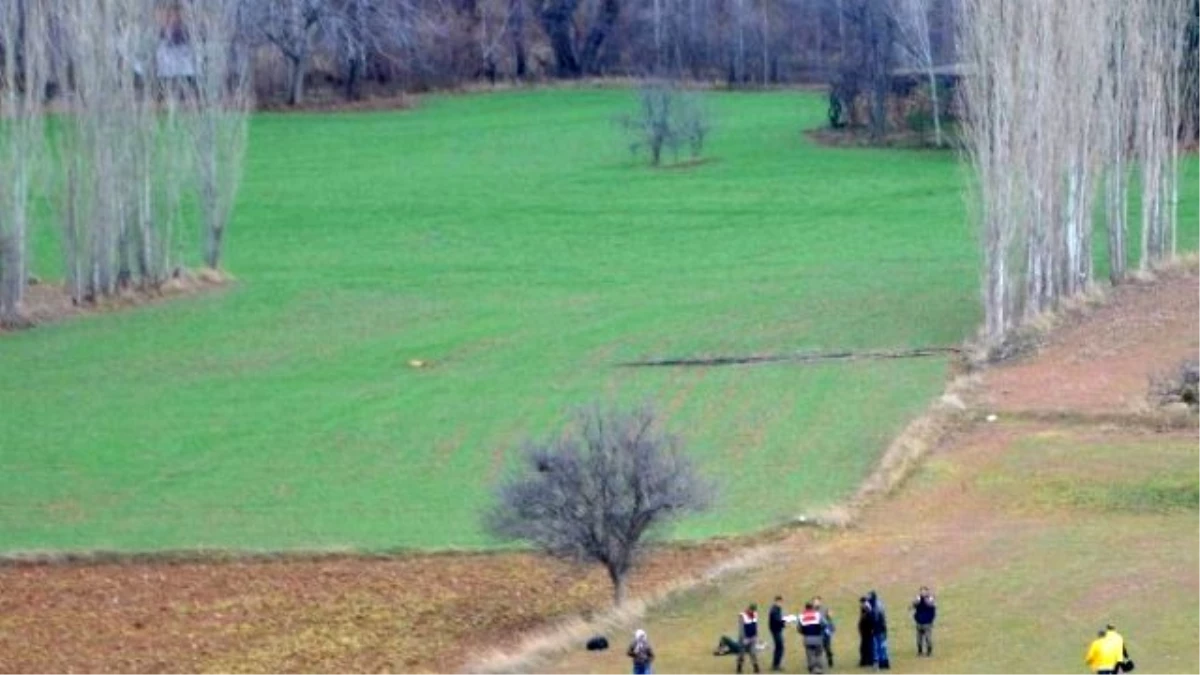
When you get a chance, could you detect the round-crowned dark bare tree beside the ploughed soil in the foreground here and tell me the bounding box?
[487,407,712,605]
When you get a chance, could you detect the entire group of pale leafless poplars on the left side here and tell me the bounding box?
[0,0,251,323]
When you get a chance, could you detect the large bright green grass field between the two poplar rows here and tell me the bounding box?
[0,91,1196,550]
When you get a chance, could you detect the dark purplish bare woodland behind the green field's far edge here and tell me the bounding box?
[213,0,954,104]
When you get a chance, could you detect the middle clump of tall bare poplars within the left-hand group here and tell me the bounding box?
[56,0,169,300]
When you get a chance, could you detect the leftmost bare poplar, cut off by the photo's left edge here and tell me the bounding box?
[0,0,49,325]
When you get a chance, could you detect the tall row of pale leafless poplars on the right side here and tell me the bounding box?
[960,0,1193,345]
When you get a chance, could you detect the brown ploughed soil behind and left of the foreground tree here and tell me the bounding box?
[0,543,732,673]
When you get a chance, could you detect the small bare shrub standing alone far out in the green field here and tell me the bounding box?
[619,82,712,166]
